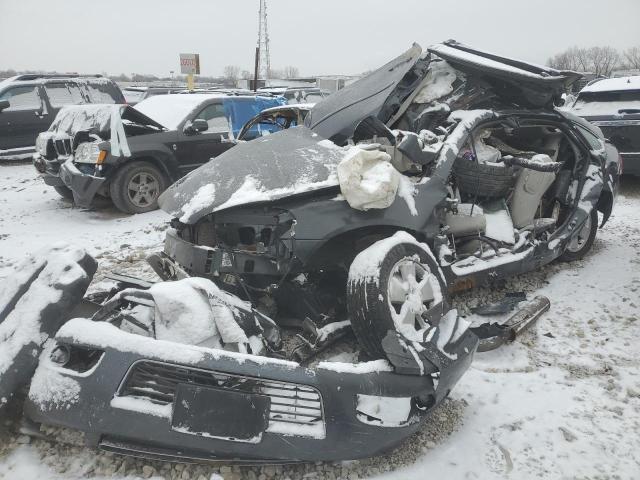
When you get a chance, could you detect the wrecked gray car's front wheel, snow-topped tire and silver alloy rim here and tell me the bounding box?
[347,240,448,358]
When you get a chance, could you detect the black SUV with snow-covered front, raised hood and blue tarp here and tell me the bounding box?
[34,94,283,213]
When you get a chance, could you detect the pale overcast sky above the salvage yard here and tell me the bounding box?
[0,0,640,75]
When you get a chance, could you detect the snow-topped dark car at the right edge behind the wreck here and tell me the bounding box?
[572,76,640,176]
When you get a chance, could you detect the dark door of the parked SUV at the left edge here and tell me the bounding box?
[0,85,49,150]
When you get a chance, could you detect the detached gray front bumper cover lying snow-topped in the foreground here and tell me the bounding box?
[25,319,478,463]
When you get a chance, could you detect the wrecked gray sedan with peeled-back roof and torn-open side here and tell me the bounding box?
[151,41,619,360]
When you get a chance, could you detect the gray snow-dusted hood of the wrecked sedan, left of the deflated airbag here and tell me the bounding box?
[158,126,348,224]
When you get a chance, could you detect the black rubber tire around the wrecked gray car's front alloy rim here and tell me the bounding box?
[347,243,449,358]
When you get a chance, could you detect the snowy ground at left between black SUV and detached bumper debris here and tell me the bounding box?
[0,163,170,281]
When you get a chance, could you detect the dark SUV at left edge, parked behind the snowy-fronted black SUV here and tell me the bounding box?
[0,74,125,156]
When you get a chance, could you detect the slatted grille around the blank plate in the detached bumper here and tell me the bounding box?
[118,360,325,438]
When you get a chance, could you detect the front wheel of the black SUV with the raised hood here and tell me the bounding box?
[109,161,168,213]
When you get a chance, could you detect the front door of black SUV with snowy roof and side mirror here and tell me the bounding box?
[176,100,234,173]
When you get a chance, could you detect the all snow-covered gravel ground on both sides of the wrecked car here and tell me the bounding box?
[0,165,640,480]
